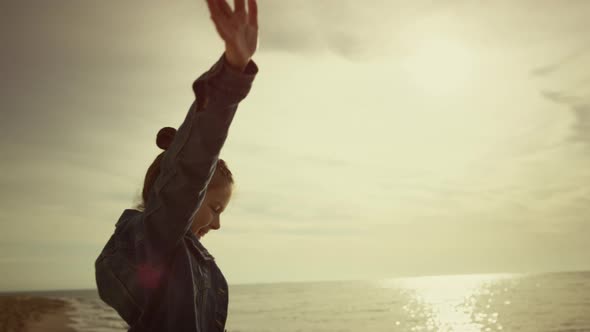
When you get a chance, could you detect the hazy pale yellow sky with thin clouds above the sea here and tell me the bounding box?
[0,0,590,291]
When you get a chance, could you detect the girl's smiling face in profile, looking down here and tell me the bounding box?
[191,174,233,240]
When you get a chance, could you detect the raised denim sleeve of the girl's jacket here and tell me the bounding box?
[137,55,258,265]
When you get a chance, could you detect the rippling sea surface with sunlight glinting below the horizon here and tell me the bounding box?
[2,271,590,332]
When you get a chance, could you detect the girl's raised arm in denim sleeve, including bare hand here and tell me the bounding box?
[136,0,258,265]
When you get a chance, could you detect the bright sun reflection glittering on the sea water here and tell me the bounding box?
[381,274,514,332]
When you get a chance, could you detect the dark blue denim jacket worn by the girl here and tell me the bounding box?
[95,55,258,332]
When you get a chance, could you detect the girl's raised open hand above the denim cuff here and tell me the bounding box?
[207,0,258,71]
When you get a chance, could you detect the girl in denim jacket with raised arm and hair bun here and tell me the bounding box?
[95,0,258,332]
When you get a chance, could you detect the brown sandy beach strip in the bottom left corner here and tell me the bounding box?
[0,295,75,332]
